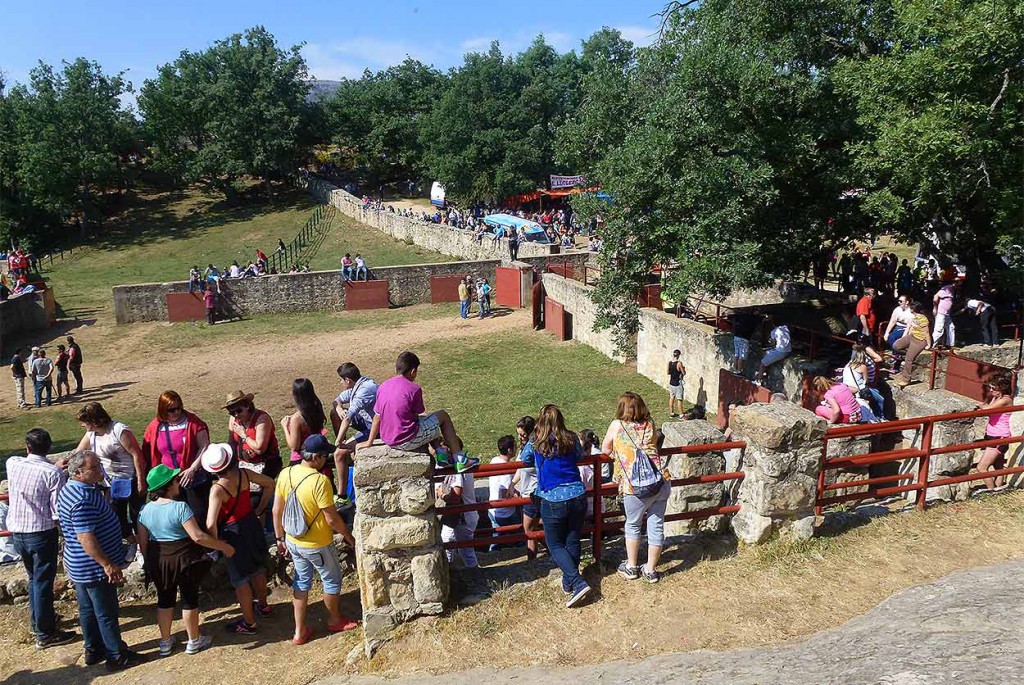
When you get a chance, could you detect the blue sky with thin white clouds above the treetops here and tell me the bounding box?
[0,0,665,98]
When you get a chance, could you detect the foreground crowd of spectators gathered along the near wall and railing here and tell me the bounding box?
[6,351,688,671]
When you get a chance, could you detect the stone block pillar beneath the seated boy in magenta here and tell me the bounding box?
[353,445,449,656]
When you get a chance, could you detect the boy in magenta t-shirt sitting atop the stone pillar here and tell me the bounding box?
[358,351,480,473]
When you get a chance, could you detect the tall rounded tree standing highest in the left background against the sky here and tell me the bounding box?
[138,27,310,198]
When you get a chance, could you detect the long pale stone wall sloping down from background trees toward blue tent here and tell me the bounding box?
[303,178,559,259]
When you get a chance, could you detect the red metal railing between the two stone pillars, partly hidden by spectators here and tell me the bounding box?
[434,441,746,559]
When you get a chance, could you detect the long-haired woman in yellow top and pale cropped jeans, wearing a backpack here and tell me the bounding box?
[602,392,672,583]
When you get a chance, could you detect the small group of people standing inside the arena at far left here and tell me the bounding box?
[10,336,85,410]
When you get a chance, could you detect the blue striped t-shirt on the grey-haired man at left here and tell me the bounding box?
[57,480,125,583]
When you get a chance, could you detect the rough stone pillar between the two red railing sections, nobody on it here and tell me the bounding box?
[730,402,826,545]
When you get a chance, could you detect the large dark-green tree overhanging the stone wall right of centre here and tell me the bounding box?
[562,0,864,346]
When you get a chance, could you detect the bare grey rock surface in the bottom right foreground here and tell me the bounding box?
[315,560,1024,685]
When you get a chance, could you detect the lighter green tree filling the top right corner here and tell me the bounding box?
[835,0,1024,264]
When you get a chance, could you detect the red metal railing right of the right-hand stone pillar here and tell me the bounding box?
[815,404,1024,515]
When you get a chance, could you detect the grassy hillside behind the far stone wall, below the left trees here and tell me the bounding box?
[37,183,451,318]
